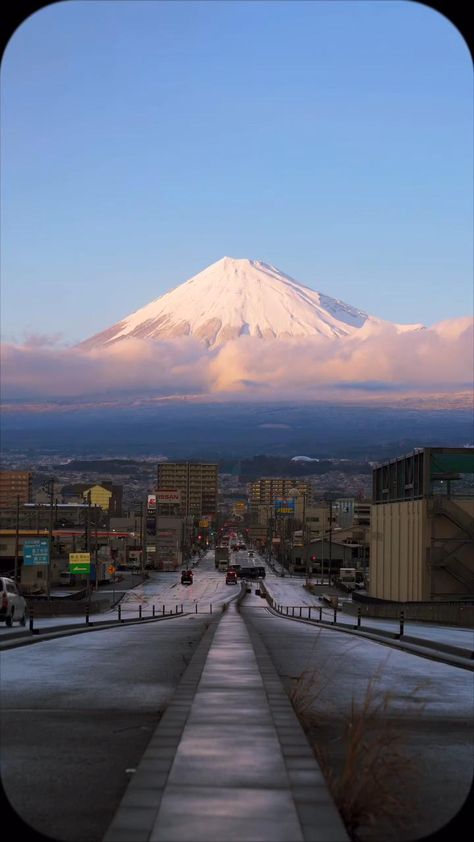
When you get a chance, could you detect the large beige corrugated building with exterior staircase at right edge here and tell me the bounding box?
[369,447,474,602]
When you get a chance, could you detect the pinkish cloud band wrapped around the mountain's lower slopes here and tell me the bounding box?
[1,318,474,403]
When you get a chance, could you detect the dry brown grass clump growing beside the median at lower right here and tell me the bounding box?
[290,667,422,840]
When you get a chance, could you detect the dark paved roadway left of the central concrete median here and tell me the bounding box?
[0,614,217,842]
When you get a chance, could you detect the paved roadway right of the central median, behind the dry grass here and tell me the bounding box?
[242,595,474,842]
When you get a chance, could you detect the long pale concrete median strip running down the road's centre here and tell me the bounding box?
[104,603,348,842]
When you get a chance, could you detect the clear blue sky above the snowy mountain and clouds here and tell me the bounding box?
[1,0,473,344]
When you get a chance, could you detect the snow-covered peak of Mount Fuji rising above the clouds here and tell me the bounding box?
[77,257,423,350]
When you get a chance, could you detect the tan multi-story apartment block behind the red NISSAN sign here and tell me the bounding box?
[156,462,219,521]
